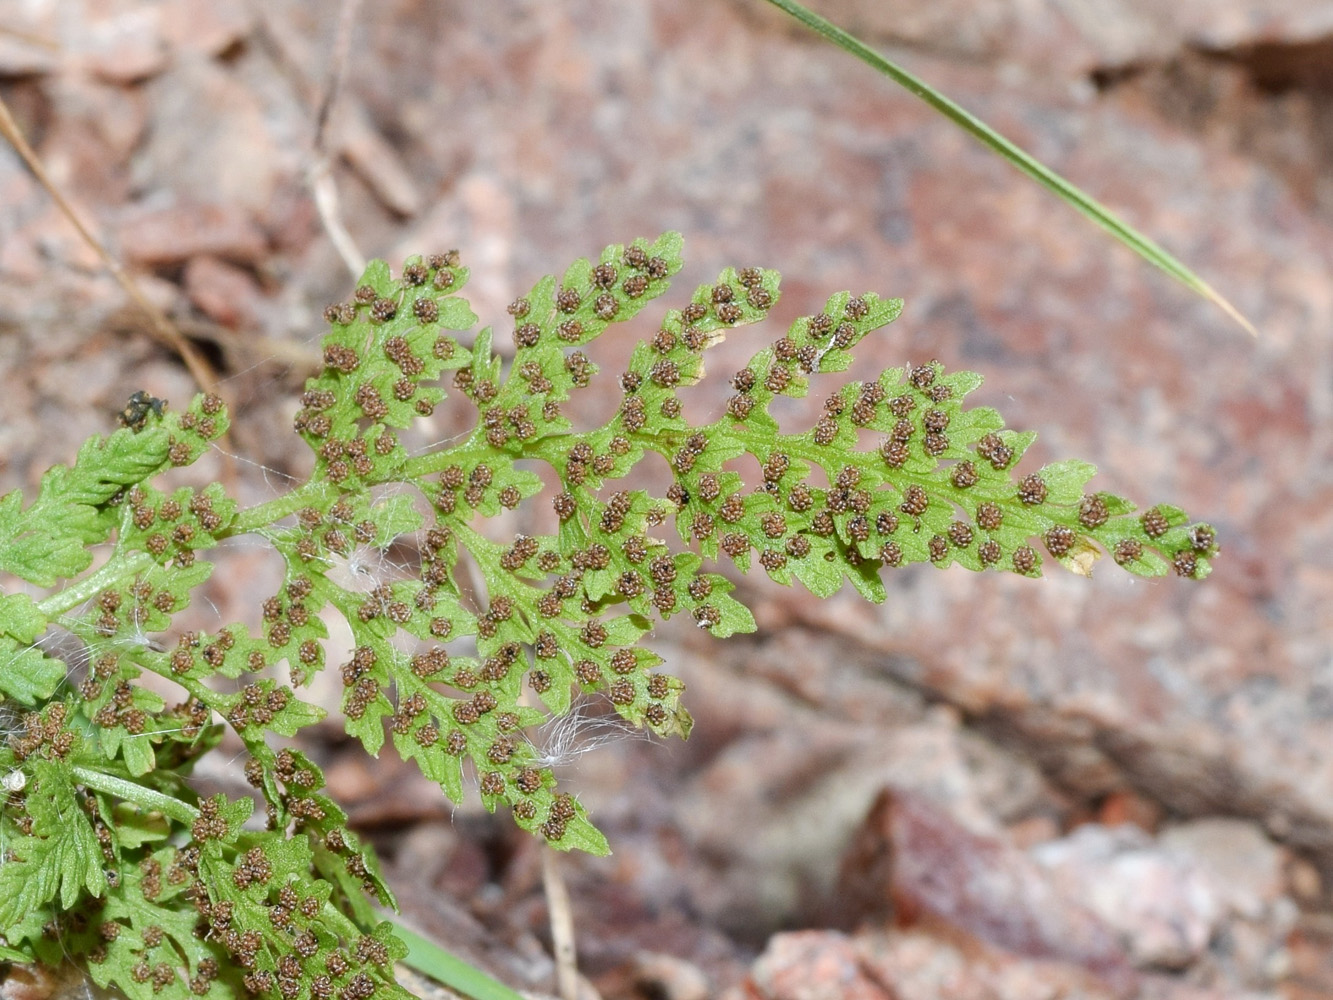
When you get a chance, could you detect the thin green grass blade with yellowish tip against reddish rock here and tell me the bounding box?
[768,0,1257,335]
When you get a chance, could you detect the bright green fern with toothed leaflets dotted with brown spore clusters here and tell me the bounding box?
[0,233,1216,1000]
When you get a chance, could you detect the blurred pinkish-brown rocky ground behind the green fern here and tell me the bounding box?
[0,0,1333,1000]
